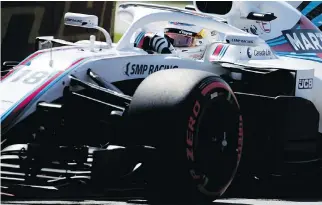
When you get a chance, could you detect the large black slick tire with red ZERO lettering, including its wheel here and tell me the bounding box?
[127,69,243,204]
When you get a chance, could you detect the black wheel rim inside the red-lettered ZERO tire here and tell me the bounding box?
[194,87,239,195]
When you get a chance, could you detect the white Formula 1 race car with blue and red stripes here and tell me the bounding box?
[0,2,322,201]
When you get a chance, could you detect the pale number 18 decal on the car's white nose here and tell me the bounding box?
[10,70,50,84]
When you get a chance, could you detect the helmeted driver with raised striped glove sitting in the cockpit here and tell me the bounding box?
[134,22,208,59]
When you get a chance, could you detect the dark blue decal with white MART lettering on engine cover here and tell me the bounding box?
[282,29,322,53]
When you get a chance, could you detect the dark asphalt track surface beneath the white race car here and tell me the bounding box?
[1,175,322,205]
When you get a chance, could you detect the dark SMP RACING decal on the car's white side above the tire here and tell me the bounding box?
[124,62,178,76]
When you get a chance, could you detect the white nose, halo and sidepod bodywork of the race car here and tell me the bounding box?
[0,3,322,133]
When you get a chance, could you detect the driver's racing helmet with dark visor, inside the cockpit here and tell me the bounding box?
[164,22,209,59]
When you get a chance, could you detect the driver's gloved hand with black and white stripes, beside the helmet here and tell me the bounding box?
[134,32,173,54]
